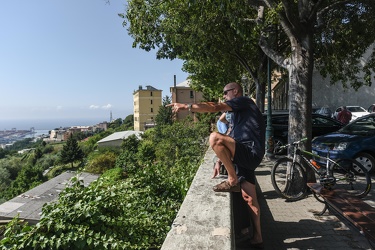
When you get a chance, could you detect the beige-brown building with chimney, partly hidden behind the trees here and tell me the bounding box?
[170,80,203,120]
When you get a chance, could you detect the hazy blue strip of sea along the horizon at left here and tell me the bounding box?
[0,118,106,130]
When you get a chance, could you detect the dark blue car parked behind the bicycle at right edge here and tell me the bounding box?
[312,113,375,171]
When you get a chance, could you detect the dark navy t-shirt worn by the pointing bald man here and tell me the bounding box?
[225,96,266,157]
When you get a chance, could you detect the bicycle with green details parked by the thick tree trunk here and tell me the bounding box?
[271,138,371,201]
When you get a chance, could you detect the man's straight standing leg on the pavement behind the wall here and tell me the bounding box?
[241,181,263,244]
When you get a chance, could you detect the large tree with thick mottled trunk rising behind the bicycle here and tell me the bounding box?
[125,0,375,182]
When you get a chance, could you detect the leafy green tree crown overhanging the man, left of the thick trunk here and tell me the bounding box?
[122,0,267,110]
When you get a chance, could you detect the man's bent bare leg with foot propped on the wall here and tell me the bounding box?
[210,132,238,186]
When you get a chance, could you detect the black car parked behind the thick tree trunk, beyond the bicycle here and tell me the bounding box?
[263,113,344,154]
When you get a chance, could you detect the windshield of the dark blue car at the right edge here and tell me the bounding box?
[337,116,375,135]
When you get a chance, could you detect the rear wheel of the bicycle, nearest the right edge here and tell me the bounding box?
[330,159,371,198]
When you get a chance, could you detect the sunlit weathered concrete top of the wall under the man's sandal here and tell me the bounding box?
[161,148,234,250]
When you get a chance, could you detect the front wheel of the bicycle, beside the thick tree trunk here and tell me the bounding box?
[271,158,307,201]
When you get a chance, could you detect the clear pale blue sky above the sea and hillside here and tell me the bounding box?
[0,0,188,129]
